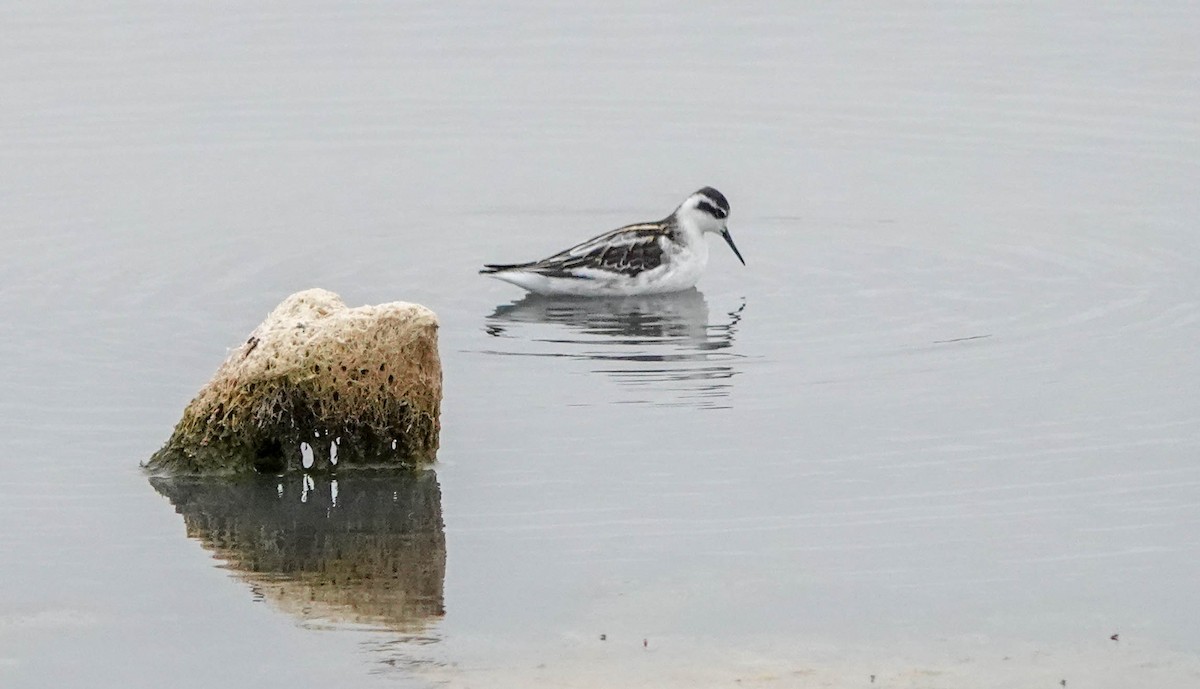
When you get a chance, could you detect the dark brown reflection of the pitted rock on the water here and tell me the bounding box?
[150,471,446,633]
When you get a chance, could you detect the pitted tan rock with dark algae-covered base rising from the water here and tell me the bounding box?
[146,289,442,473]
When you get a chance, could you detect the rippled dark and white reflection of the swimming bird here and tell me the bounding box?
[486,289,745,408]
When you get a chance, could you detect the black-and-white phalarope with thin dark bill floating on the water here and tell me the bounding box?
[480,186,746,296]
